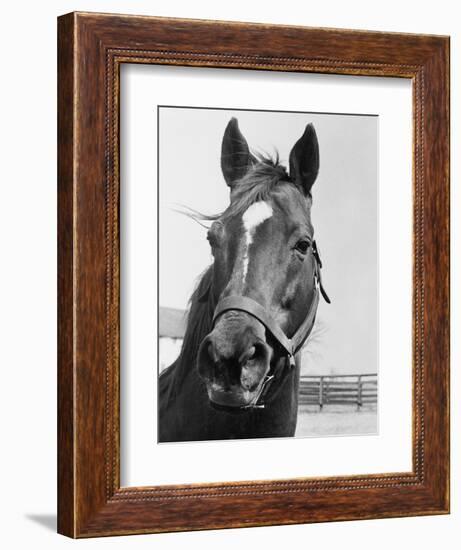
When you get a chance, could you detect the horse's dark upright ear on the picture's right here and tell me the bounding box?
[290,124,319,196]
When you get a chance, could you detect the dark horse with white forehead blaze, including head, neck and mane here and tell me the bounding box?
[158,118,330,442]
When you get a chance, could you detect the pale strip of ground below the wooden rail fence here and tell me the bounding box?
[296,405,378,437]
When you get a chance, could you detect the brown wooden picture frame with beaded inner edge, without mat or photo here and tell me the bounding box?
[58,13,449,537]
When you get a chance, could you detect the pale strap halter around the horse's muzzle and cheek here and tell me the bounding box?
[213,241,330,409]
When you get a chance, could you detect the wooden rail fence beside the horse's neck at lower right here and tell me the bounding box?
[299,374,378,410]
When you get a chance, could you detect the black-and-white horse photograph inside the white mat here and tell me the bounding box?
[158,105,379,443]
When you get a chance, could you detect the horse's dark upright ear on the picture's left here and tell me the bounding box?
[221,118,253,189]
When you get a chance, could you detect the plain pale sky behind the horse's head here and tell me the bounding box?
[159,107,379,374]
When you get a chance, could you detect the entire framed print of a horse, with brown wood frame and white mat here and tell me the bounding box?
[58,13,449,537]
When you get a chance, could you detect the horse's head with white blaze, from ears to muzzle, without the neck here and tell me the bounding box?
[197,122,321,410]
